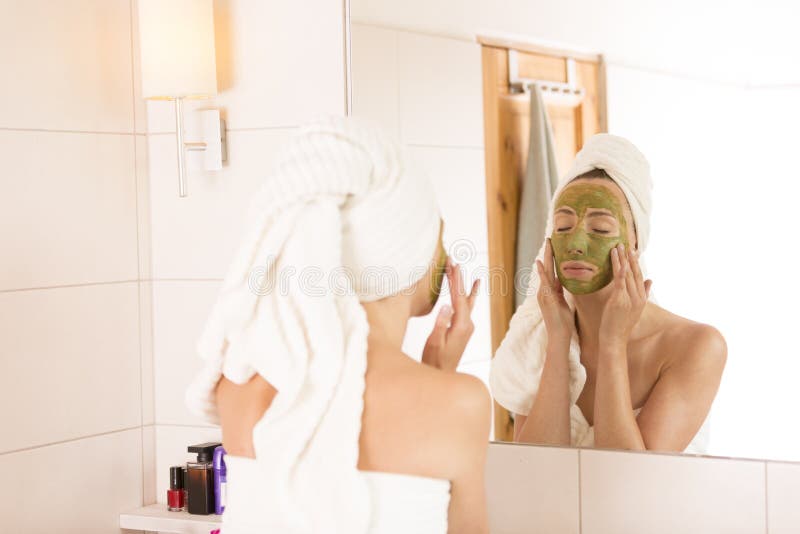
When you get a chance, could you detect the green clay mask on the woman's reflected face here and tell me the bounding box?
[550,183,628,295]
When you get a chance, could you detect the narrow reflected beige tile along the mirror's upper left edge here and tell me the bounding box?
[351,24,400,139]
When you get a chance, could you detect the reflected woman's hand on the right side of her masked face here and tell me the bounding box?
[600,243,653,344]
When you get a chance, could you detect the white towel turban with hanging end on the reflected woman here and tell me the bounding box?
[489,134,653,428]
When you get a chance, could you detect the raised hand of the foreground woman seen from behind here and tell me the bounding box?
[422,258,480,371]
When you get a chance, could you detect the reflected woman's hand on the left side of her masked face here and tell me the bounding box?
[536,237,575,343]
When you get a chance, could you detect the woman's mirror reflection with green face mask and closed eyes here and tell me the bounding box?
[491,134,727,453]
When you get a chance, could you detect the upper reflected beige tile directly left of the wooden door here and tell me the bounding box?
[397,32,483,147]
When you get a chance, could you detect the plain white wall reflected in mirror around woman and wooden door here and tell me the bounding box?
[352,0,800,459]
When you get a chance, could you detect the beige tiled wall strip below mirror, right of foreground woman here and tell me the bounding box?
[486,443,800,534]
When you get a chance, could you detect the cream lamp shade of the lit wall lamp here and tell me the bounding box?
[137,0,217,99]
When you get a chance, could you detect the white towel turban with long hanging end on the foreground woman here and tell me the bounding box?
[186,118,440,534]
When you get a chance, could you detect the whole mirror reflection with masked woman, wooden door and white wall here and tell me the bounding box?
[351,0,800,460]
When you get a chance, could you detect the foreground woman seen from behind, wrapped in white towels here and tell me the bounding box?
[187,118,491,534]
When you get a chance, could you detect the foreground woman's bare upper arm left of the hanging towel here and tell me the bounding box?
[216,374,278,458]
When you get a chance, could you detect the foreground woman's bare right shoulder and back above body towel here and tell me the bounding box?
[362,350,492,480]
